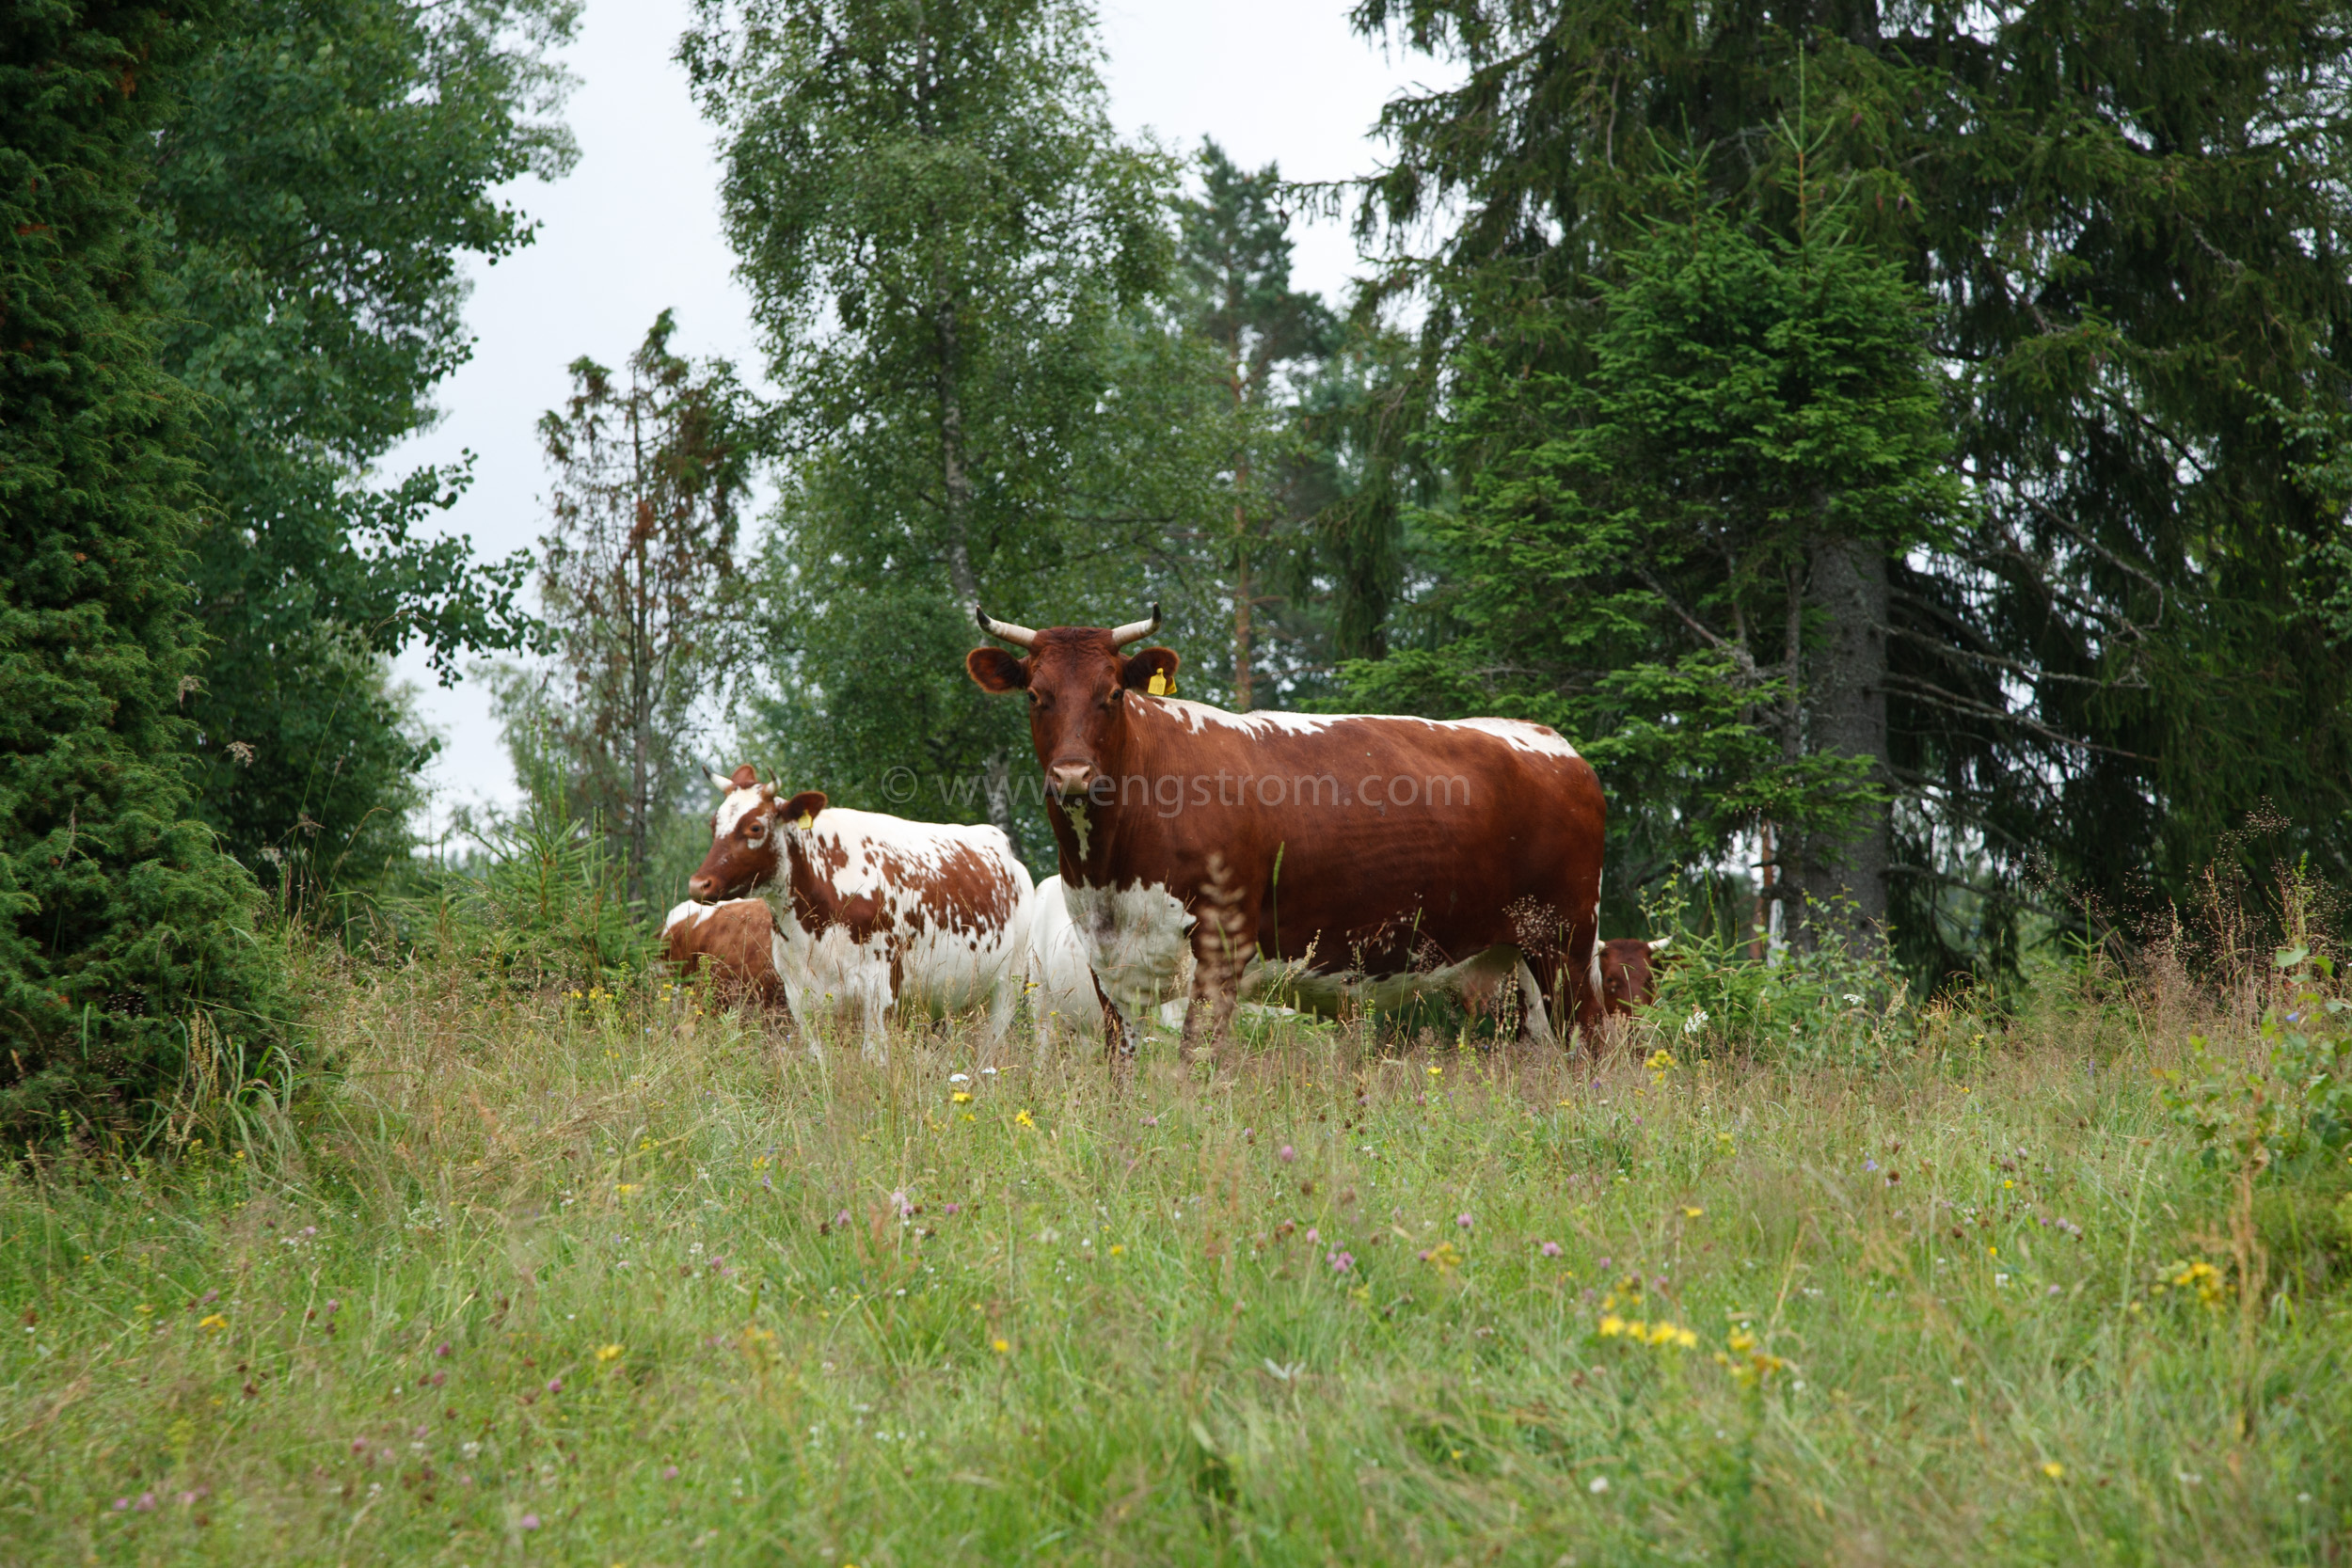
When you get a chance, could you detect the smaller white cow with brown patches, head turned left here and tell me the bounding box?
[687,767,1033,1053]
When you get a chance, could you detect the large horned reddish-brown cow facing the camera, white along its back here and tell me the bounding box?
[964,607,1604,1055]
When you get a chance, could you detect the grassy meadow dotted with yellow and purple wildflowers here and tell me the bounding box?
[0,949,2352,1568]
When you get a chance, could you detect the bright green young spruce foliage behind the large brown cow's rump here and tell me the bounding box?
[1348,169,1962,919]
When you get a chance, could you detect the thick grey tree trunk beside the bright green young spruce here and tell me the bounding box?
[1804,538,1889,950]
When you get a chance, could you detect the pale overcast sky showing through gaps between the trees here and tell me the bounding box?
[384,0,1439,816]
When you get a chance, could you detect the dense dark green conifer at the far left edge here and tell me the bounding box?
[0,5,282,1143]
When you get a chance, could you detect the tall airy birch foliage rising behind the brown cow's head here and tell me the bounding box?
[680,0,1228,864]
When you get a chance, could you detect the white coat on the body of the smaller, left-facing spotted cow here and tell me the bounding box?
[760,806,1035,1055]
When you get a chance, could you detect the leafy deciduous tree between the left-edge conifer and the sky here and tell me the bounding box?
[146,0,579,883]
